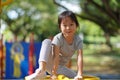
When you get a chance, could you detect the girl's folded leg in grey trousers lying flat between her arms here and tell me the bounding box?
[57,66,77,78]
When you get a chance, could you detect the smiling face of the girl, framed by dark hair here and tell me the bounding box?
[60,17,77,37]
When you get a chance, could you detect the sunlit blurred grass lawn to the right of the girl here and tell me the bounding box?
[71,45,120,74]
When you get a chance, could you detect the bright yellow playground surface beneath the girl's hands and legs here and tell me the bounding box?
[25,75,100,80]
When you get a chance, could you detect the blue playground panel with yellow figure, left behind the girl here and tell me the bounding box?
[3,42,41,79]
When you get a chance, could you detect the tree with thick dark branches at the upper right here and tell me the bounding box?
[53,0,120,46]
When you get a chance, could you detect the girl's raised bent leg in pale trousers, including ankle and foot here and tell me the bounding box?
[27,39,52,80]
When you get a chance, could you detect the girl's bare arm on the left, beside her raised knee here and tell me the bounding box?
[52,45,59,76]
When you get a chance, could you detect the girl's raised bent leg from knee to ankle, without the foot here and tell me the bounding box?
[38,39,53,72]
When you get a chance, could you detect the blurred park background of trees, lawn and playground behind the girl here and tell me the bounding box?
[0,0,120,80]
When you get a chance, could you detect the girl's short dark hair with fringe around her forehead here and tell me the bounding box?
[58,11,79,28]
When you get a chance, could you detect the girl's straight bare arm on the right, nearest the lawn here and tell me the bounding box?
[76,49,83,78]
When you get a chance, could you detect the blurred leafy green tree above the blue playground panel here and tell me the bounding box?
[1,0,58,41]
